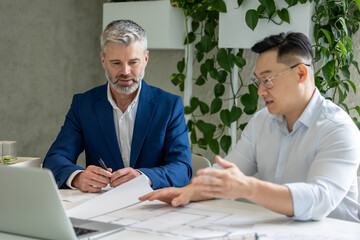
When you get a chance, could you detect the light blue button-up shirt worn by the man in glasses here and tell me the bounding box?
[226,89,360,222]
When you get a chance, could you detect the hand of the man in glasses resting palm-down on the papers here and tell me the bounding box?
[139,184,194,207]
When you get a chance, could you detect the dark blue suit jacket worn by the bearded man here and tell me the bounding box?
[43,80,192,189]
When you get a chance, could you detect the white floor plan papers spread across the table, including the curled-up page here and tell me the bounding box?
[67,176,352,240]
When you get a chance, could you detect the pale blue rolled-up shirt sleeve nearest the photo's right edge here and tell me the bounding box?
[286,125,360,220]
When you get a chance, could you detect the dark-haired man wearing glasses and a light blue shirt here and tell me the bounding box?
[140,33,360,222]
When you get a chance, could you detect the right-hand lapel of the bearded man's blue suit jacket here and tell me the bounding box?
[130,80,156,167]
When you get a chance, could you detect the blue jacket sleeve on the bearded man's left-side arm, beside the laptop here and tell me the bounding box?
[43,95,84,188]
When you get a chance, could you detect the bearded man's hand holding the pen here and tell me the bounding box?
[71,165,112,192]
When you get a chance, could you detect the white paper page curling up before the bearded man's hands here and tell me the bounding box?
[67,175,153,219]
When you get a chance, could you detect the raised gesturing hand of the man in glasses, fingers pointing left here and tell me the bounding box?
[192,156,251,199]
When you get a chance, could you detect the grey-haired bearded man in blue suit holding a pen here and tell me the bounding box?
[43,20,192,192]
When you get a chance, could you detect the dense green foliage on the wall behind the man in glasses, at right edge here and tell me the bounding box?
[312,0,360,126]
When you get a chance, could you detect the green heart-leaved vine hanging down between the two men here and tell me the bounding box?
[171,0,258,154]
